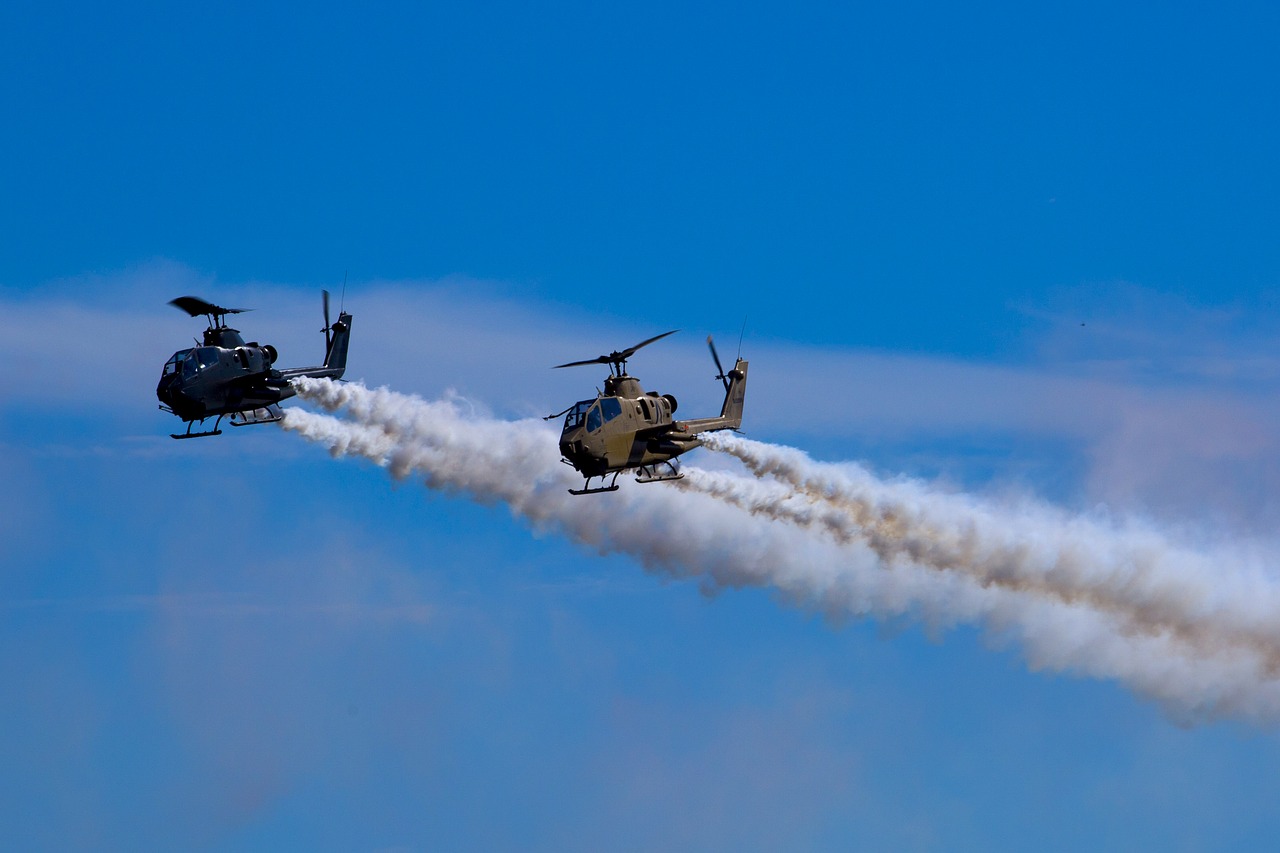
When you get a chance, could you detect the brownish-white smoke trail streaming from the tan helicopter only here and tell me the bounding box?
[678,450,1280,676]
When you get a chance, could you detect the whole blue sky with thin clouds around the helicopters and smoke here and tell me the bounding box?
[0,4,1280,850]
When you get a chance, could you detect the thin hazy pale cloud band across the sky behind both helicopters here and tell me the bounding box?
[10,261,1280,528]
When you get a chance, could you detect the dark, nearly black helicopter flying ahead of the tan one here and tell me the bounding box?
[156,291,351,438]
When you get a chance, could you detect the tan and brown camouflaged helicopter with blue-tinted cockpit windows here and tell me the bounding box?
[544,329,746,494]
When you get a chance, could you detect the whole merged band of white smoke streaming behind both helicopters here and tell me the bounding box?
[283,379,1280,721]
